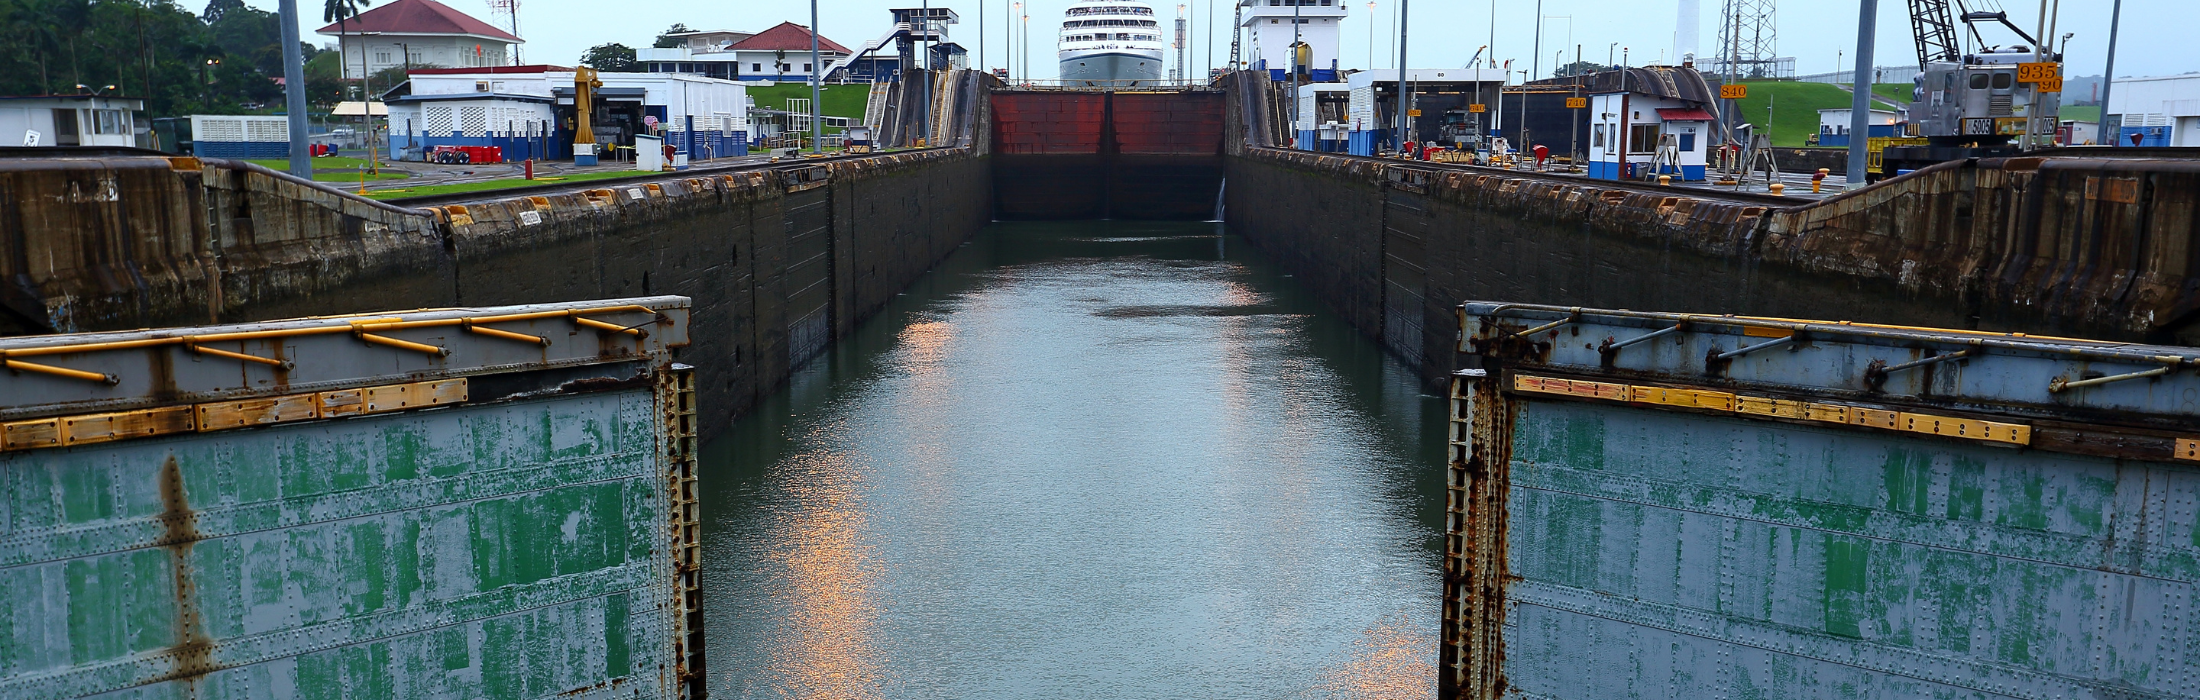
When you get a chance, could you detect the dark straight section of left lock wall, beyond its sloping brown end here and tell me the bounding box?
[444,150,992,427]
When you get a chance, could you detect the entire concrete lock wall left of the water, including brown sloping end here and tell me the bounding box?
[0,70,992,434]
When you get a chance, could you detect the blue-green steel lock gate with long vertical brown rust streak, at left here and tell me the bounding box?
[0,297,702,698]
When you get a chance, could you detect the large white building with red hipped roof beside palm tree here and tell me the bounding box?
[317,0,526,79]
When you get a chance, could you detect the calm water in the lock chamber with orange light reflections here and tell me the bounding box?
[702,222,1443,700]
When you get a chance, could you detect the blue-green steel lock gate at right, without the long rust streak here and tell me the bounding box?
[1439,302,2200,700]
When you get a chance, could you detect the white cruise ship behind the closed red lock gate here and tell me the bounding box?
[1058,0,1166,88]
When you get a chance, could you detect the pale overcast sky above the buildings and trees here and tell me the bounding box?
[261,0,2200,77]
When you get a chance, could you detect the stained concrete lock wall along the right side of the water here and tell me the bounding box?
[1225,70,2200,381]
